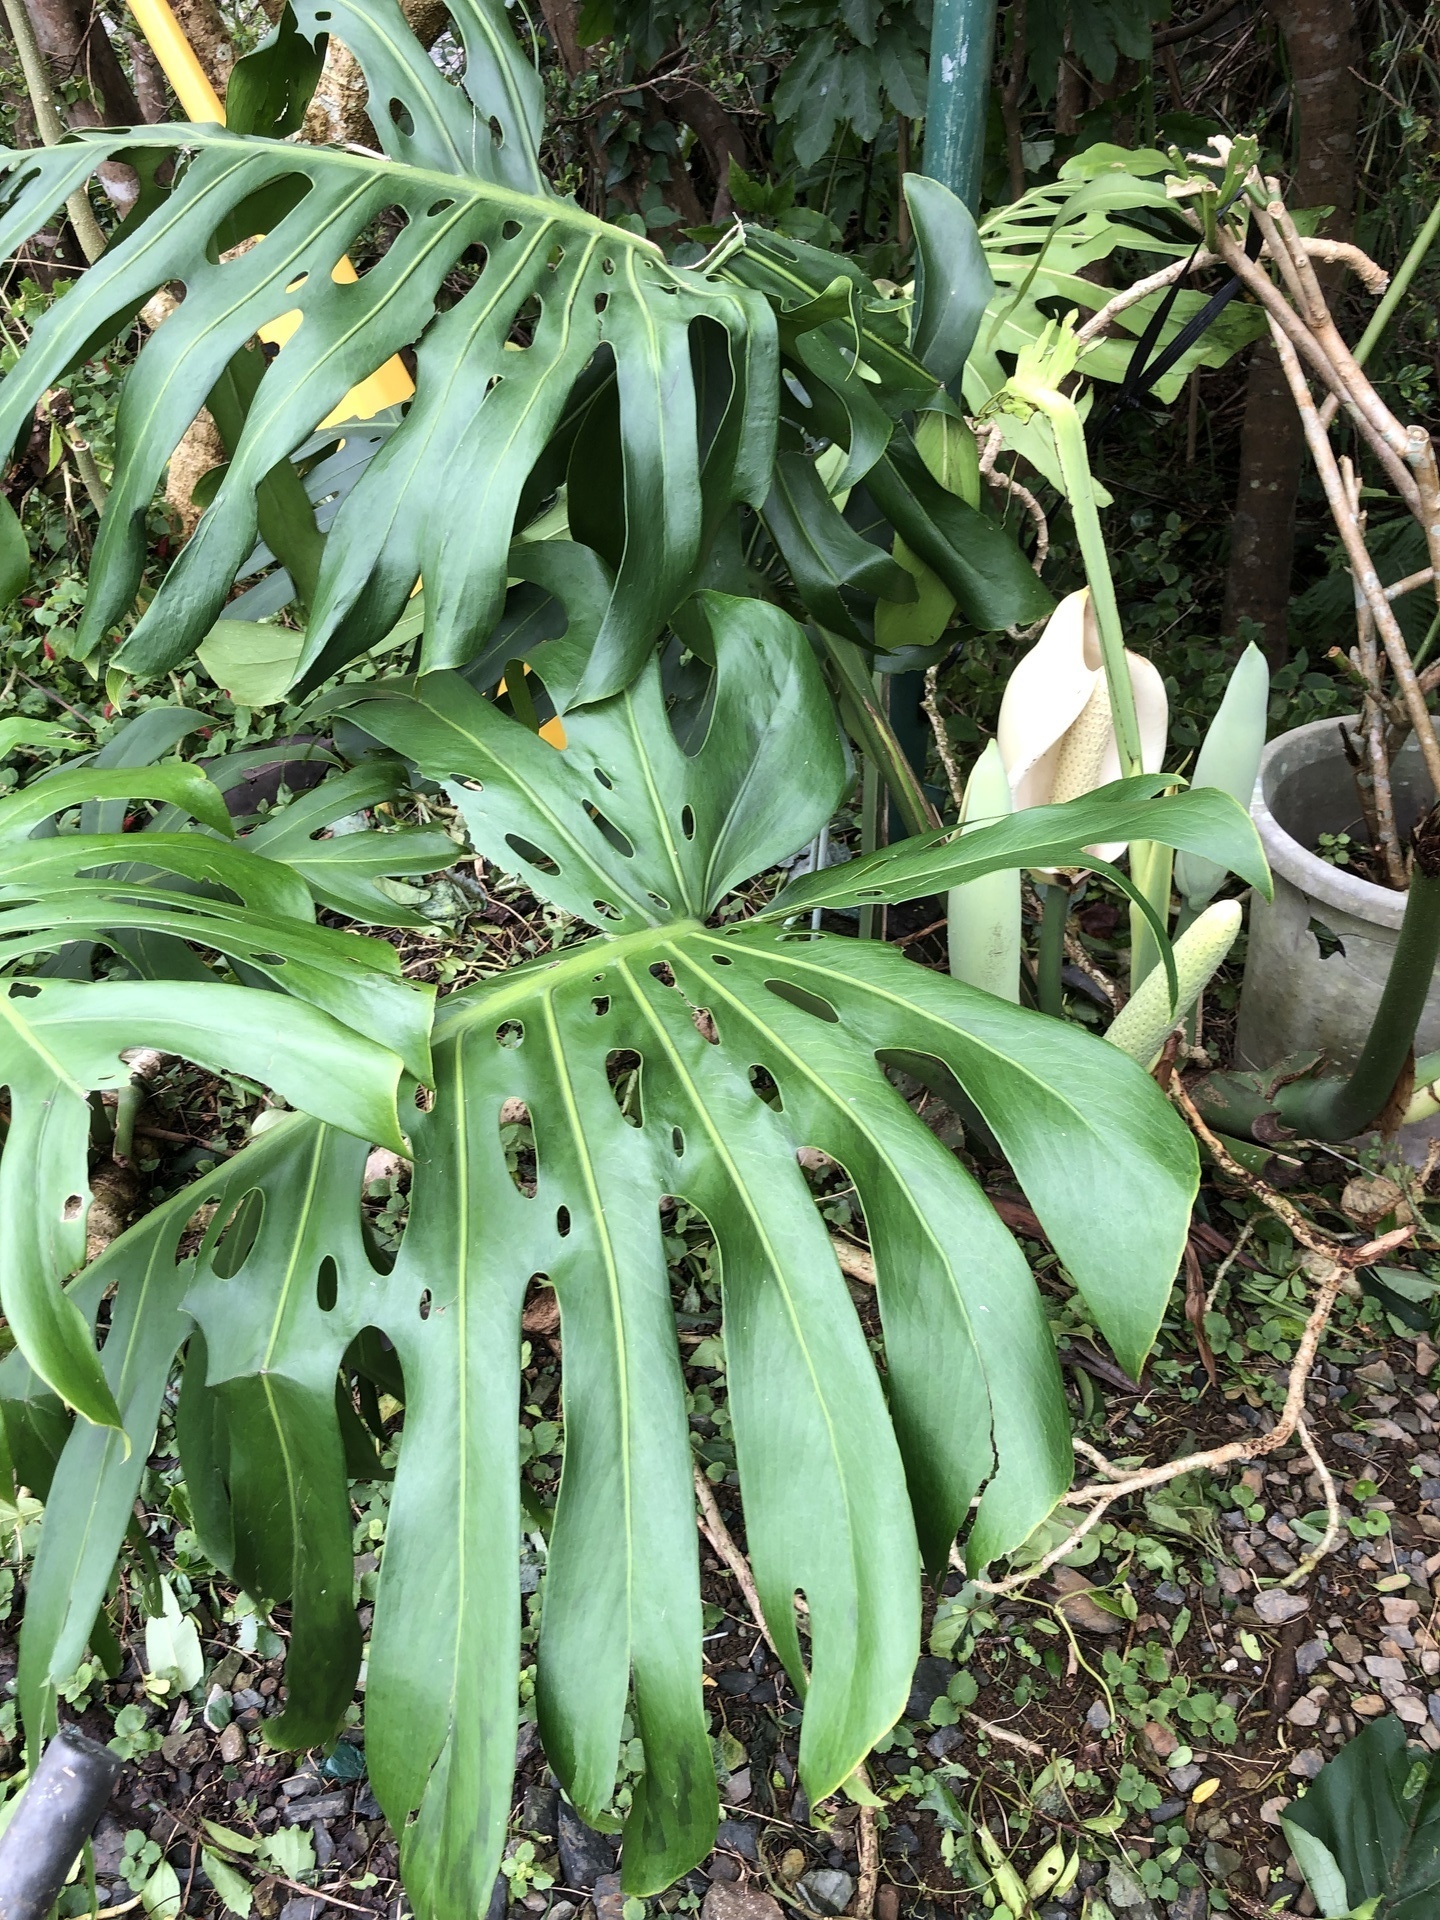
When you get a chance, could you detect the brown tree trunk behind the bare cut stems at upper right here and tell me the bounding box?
[1225,0,1361,666]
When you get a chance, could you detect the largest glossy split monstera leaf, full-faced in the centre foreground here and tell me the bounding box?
[10,595,1265,1920]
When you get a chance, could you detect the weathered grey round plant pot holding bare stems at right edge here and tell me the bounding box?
[1236,720,1440,1146]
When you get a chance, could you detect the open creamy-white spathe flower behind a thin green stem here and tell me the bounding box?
[996,588,1169,860]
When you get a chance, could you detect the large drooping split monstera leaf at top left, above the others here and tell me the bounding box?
[0,0,776,699]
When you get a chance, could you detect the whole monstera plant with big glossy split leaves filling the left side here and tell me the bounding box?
[0,0,1265,1920]
